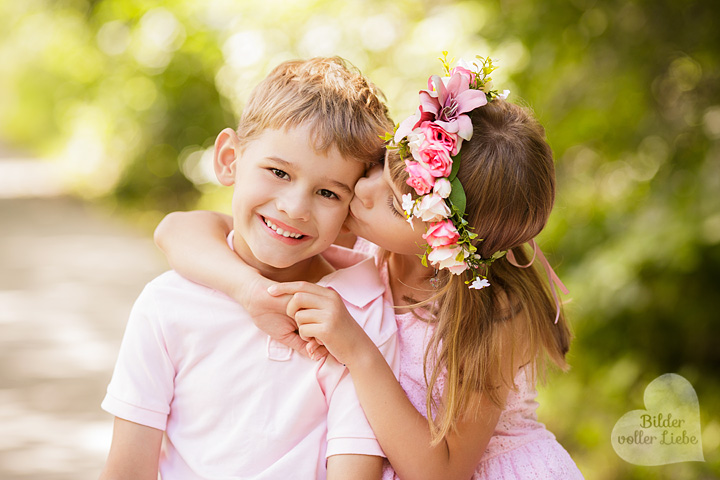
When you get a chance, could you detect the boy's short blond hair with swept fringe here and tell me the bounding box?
[237,57,393,163]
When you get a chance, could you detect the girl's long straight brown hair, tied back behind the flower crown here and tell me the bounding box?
[387,99,571,442]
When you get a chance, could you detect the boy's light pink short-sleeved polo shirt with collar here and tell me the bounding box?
[102,240,398,480]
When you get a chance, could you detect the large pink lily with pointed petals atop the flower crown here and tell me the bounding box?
[416,71,487,140]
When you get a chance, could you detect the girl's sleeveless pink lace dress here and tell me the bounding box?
[355,239,583,480]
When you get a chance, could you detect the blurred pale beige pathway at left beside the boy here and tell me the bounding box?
[0,157,167,480]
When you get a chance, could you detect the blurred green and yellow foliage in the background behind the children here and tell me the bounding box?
[0,0,720,479]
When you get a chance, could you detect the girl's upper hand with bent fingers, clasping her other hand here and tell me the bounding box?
[268,282,375,366]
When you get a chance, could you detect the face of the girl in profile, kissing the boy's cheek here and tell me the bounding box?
[345,159,426,255]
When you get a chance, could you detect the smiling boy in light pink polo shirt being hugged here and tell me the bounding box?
[101,58,397,480]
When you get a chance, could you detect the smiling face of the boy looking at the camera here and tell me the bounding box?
[215,126,364,279]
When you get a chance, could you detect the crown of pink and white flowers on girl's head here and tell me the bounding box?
[385,52,510,290]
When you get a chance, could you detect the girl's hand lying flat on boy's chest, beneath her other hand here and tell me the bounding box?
[243,276,327,360]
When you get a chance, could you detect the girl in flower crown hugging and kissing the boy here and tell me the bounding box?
[156,58,582,480]
